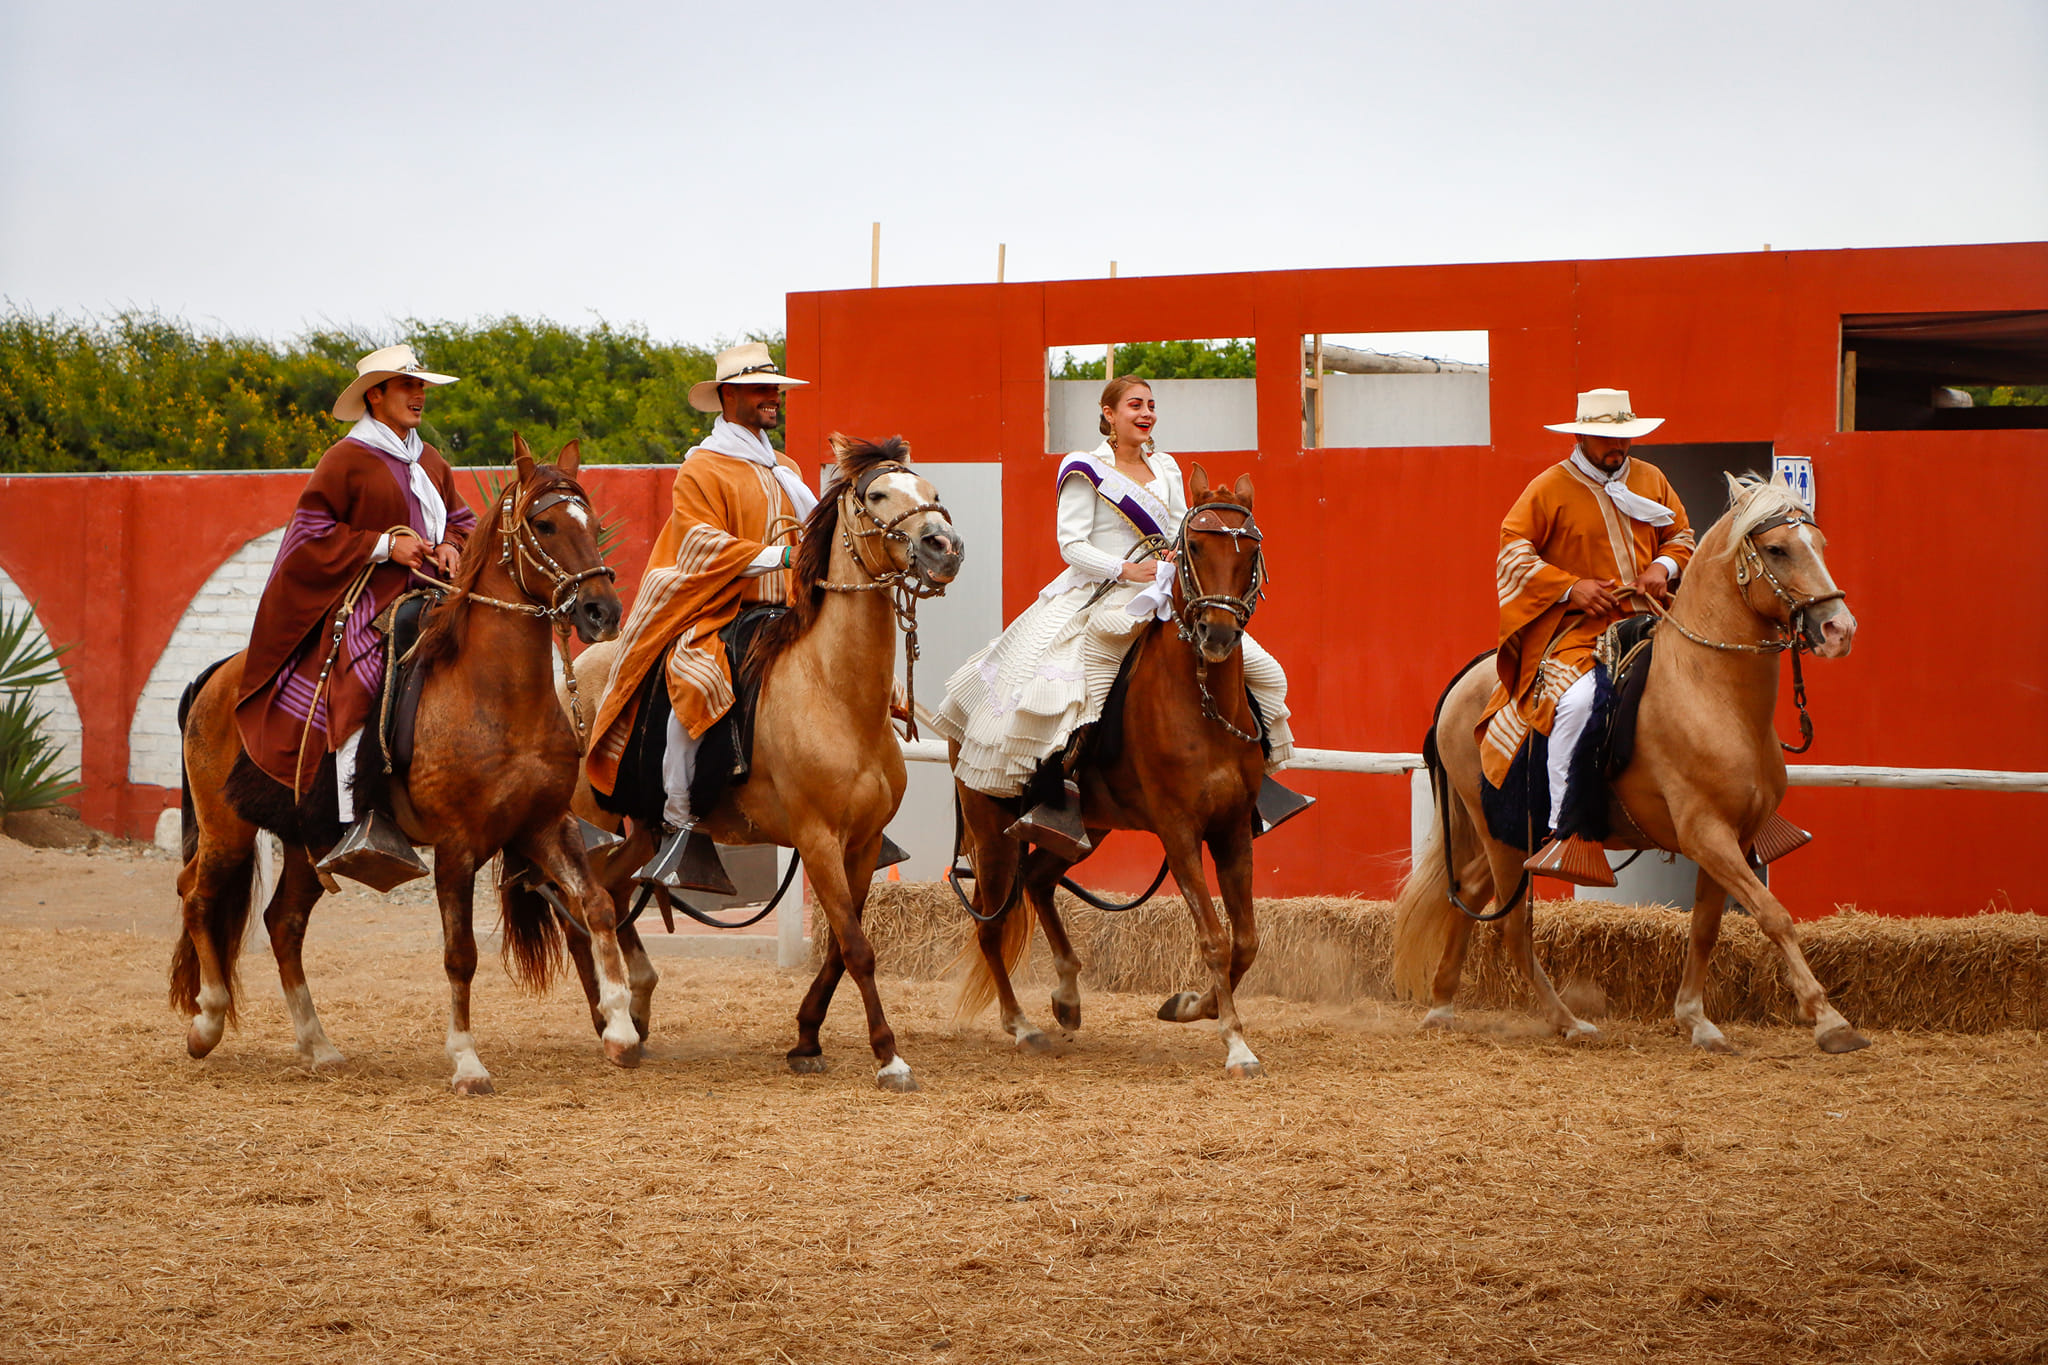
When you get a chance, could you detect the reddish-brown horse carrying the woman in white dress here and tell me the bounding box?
[952,465,1266,1076]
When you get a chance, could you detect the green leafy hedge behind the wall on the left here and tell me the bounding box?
[0,309,782,473]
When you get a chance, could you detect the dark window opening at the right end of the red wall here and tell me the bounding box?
[1841,309,2048,432]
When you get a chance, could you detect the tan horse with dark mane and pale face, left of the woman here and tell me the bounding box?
[571,434,965,1091]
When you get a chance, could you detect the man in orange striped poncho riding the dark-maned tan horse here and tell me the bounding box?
[586,342,817,892]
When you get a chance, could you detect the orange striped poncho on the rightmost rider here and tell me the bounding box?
[1479,456,1694,786]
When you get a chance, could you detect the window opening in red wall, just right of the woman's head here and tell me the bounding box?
[1300,332,1493,448]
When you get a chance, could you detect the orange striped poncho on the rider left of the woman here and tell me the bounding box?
[586,448,797,792]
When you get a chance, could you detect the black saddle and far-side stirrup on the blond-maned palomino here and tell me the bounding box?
[1556,616,1812,868]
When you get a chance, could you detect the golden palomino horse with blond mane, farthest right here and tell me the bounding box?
[1393,479,1868,1052]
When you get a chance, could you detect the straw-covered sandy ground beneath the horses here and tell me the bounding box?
[0,843,2048,1365]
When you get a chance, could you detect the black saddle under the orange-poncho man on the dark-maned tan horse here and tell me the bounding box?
[596,604,788,825]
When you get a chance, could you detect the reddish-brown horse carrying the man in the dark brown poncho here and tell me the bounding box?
[170,438,639,1095]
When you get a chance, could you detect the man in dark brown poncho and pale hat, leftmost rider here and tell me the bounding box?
[236,346,477,825]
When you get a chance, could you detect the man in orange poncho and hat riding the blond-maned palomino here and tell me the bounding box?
[1479,389,1694,886]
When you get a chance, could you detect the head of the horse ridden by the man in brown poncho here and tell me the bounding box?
[504,434,625,645]
